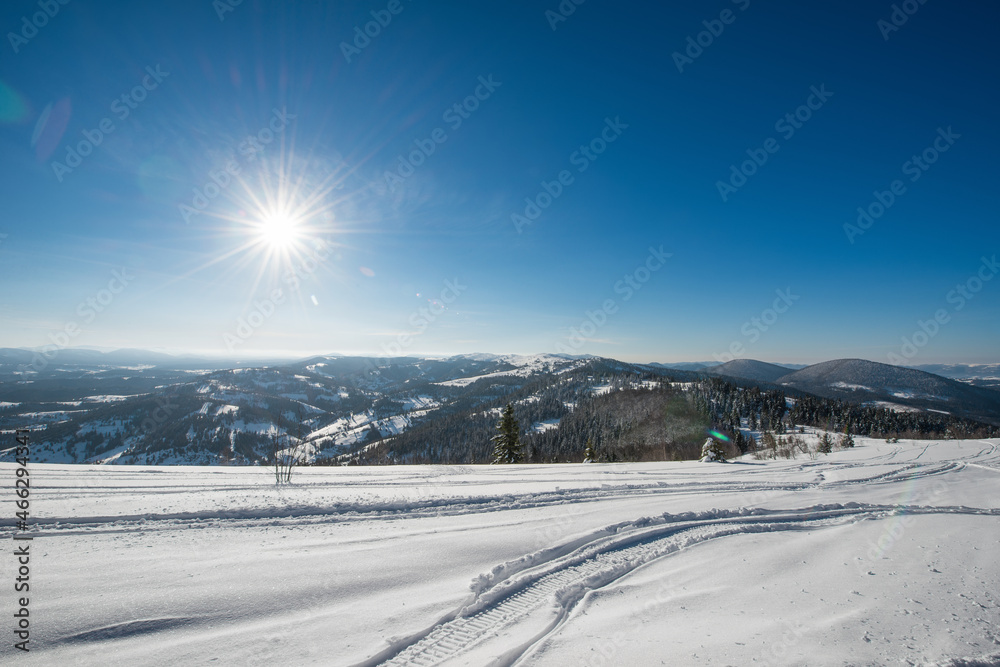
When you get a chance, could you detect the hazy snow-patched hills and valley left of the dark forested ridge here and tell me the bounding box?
[0,350,627,464]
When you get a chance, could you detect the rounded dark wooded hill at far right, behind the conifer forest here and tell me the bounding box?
[773,359,1000,423]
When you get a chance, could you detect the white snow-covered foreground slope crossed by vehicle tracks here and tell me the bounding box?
[0,438,1000,666]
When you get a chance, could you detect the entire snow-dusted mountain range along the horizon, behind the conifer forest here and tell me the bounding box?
[0,349,1000,464]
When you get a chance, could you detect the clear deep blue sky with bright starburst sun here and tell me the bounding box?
[0,0,1000,364]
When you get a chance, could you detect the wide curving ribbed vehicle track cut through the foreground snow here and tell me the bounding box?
[357,503,1000,667]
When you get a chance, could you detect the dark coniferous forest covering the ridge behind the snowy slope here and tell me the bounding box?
[352,374,1000,464]
